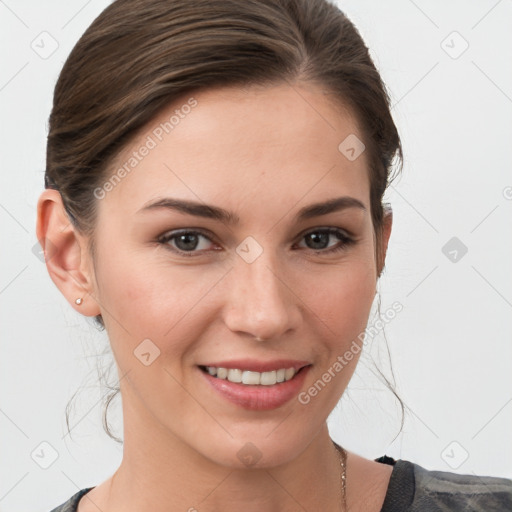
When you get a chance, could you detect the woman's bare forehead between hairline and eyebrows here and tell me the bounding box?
[101,84,369,219]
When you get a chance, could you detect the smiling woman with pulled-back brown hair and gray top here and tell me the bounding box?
[37,0,512,512]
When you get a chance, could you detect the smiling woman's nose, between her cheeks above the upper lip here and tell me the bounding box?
[224,251,302,341]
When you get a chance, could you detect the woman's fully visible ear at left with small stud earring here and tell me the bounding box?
[36,189,100,316]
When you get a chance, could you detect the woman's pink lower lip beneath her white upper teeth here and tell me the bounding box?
[198,366,310,411]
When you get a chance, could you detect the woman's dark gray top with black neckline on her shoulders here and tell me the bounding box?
[51,455,512,512]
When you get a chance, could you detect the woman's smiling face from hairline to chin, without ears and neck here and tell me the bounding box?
[87,85,377,467]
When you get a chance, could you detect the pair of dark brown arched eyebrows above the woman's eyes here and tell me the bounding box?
[137,196,366,225]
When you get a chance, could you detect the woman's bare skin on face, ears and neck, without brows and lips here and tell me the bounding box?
[37,84,392,512]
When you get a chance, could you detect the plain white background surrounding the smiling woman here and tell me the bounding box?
[0,0,512,512]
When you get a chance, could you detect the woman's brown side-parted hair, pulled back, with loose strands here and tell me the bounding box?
[45,0,404,442]
